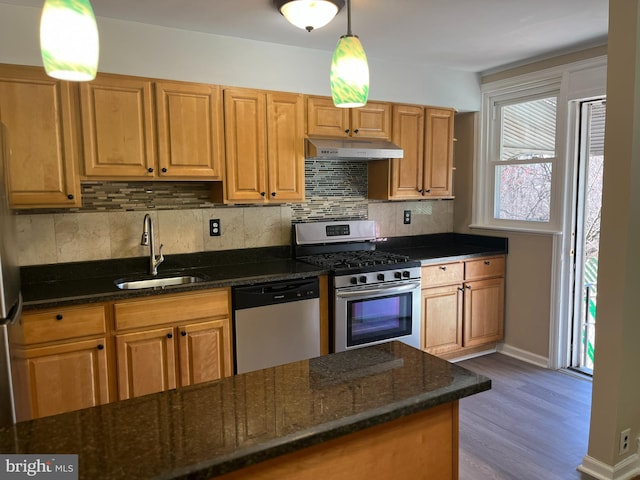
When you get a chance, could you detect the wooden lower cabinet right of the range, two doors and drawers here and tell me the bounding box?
[421,256,505,358]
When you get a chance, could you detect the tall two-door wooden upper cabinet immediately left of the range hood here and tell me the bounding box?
[224,89,304,203]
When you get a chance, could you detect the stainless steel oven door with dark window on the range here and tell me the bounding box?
[333,279,420,352]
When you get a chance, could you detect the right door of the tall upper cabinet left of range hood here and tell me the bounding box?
[267,93,304,202]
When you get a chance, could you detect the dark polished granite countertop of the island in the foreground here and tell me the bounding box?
[0,342,491,480]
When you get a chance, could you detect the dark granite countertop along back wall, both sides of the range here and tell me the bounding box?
[21,233,507,310]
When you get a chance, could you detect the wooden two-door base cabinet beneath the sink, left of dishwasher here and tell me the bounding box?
[114,289,233,400]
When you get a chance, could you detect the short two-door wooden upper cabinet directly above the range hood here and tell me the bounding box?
[307,96,391,140]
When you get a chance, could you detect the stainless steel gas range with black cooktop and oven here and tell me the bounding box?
[293,220,420,352]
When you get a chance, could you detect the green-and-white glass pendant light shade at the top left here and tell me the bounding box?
[40,0,100,81]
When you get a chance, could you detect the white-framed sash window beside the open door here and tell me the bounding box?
[474,82,559,231]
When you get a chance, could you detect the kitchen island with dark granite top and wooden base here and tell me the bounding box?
[0,342,491,480]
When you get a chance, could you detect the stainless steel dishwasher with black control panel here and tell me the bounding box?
[233,277,320,373]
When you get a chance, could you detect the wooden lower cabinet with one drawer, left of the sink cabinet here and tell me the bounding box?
[9,304,112,421]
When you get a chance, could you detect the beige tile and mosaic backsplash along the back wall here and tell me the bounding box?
[17,161,453,265]
